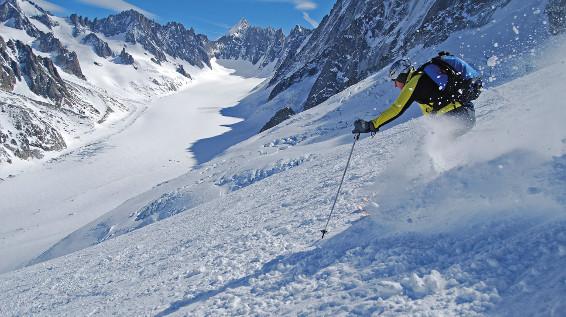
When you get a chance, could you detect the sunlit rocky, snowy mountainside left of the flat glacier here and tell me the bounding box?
[0,0,210,168]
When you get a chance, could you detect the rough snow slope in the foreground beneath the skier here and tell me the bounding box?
[0,29,566,316]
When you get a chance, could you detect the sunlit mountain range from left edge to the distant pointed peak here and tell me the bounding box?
[0,0,316,165]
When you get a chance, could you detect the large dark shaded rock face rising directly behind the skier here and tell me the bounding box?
[270,0,510,109]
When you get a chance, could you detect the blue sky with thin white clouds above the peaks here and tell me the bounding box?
[32,0,335,39]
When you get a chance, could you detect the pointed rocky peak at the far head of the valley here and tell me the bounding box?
[208,19,285,67]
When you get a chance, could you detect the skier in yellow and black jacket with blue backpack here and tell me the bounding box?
[352,52,482,135]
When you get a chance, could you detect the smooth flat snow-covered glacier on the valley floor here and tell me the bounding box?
[0,60,261,272]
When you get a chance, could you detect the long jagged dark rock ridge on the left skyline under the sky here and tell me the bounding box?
[69,10,210,68]
